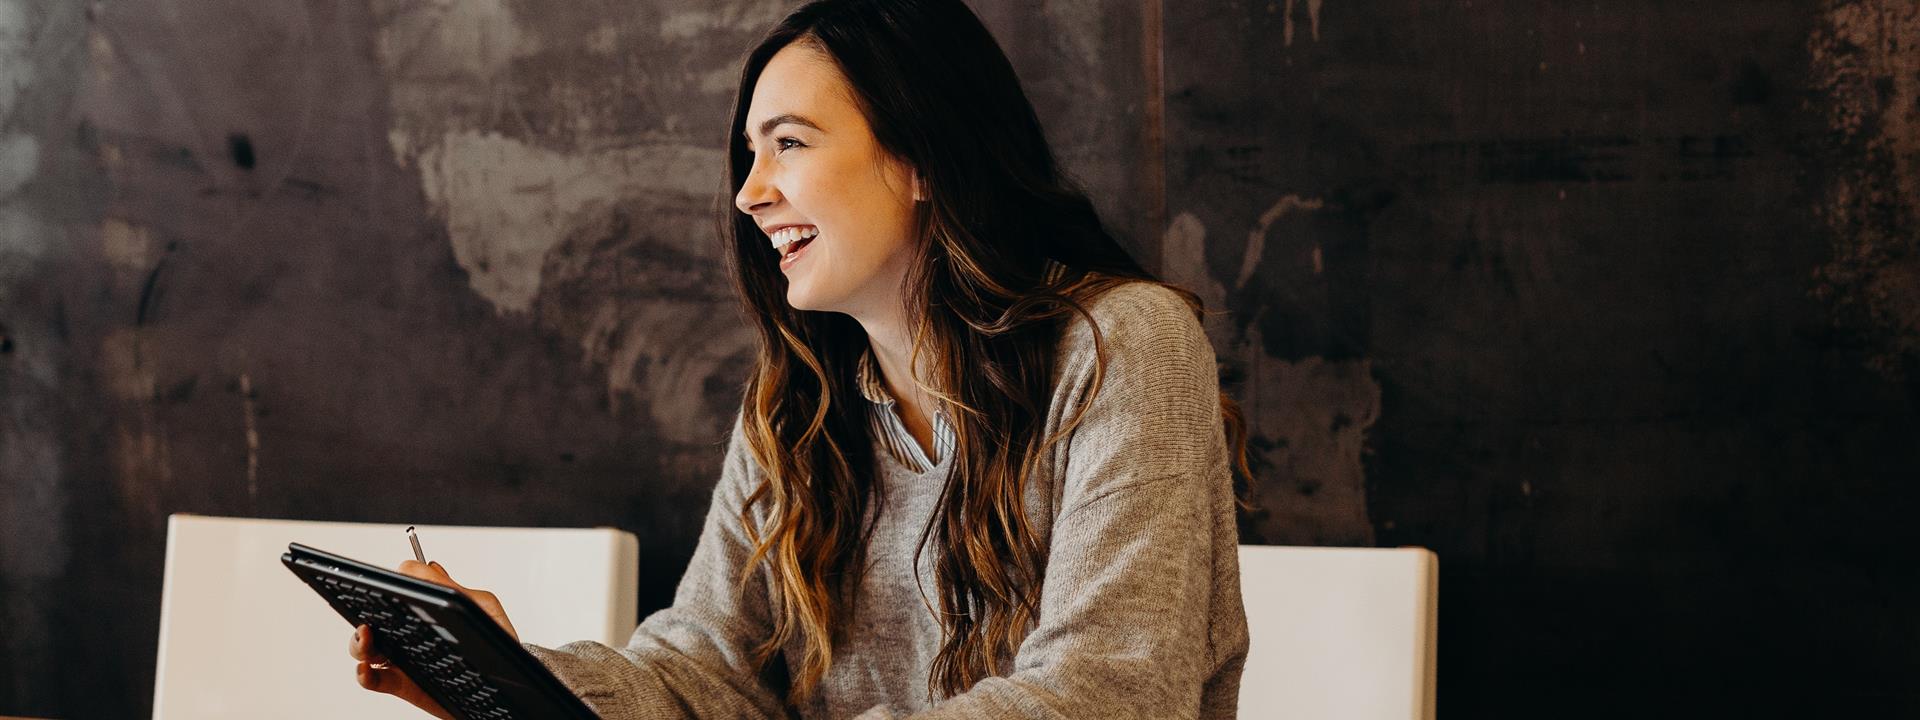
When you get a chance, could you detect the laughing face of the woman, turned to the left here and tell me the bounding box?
[733,42,914,319]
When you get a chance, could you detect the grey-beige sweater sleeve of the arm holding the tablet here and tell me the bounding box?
[526,410,783,720]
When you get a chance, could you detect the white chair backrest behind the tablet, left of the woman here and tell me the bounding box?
[154,515,639,720]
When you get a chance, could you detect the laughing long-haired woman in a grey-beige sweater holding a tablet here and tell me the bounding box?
[351,0,1246,718]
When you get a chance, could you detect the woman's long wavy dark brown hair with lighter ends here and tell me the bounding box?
[722,0,1246,703]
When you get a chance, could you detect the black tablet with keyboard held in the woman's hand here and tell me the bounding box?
[280,543,597,720]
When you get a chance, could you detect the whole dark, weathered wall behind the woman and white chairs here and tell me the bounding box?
[0,0,1920,718]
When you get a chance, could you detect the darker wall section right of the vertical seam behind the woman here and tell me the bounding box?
[1165,0,1920,718]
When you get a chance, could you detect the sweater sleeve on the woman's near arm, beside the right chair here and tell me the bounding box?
[862,286,1244,720]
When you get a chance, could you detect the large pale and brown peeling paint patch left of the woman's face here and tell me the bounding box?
[380,0,760,456]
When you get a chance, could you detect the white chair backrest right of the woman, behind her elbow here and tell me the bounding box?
[1240,545,1440,720]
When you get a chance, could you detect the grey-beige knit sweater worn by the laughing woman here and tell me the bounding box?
[526,282,1246,720]
